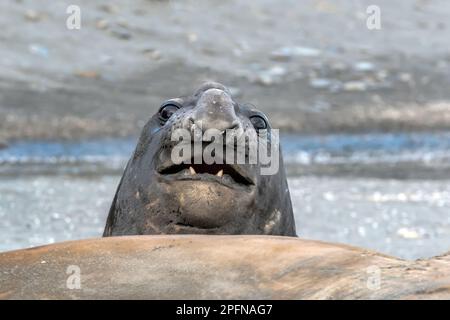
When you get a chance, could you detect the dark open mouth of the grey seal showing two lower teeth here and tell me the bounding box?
[159,163,254,186]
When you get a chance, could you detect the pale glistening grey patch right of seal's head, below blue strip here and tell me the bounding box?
[289,177,450,259]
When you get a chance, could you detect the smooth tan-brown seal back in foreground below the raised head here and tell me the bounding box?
[0,235,450,299]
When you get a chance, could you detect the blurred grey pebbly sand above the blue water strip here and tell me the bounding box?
[0,0,450,142]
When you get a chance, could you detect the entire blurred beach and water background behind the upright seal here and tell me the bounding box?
[0,0,450,259]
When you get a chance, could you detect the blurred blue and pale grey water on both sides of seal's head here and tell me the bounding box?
[0,133,450,259]
